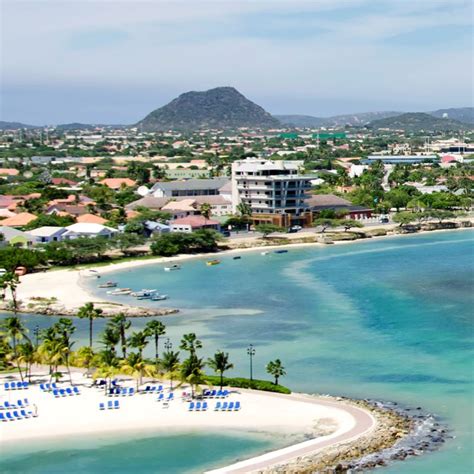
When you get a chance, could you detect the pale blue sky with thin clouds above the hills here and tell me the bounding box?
[0,0,474,125]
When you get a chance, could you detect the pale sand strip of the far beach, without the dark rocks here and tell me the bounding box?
[10,228,472,315]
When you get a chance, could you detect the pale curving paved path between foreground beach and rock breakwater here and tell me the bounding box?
[207,393,377,474]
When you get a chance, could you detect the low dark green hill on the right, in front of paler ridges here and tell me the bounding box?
[368,112,472,132]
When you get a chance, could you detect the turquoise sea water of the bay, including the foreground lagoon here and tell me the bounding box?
[0,231,474,474]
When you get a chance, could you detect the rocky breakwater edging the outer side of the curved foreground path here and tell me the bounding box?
[258,397,451,474]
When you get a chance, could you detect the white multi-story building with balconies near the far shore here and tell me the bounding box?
[232,158,313,227]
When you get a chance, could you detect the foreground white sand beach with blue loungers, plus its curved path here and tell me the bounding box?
[0,369,377,472]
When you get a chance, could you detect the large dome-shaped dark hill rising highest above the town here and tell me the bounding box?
[136,87,280,131]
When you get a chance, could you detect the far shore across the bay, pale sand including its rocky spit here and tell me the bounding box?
[10,223,473,317]
